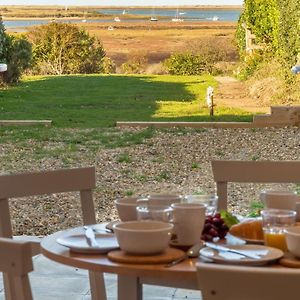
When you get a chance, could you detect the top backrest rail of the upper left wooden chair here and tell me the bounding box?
[0,167,95,199]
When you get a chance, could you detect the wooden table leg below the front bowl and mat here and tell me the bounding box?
[118,275,143,300]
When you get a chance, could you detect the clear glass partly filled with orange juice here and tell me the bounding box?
[261,209,296,252]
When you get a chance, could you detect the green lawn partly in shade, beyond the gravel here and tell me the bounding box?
[0,75,251,128]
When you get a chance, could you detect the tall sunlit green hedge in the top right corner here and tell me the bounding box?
[236,0,300,84]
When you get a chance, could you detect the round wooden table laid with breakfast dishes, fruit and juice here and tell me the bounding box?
[41,190,300,300]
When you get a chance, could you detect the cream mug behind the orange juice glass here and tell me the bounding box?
[260,190,298,210]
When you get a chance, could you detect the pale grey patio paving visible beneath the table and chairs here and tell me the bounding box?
[0,250,201,300]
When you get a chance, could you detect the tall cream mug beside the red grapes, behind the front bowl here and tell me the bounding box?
[171,203,206,246]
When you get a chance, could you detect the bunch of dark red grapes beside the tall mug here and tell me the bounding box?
[201,213,229,241]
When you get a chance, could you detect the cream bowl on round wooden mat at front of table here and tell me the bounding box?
[113,221,173,255]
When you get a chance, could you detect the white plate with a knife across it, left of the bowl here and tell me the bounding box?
[56,233,119,253]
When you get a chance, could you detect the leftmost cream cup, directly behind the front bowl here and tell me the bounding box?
[115,197,138,222]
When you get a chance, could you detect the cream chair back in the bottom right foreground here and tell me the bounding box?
[197,262,300,300]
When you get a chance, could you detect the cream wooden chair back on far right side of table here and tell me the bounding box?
[211,160,300,210]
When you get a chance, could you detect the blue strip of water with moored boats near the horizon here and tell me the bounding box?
[4,9,241,30]
